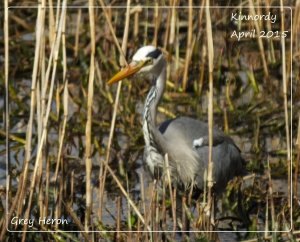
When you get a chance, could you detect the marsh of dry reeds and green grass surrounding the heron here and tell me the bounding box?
[0,0,300,241]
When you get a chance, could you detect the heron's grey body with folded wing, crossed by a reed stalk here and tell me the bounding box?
[156,117,243,190]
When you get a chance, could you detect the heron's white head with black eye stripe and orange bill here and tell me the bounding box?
[107,45,166,84]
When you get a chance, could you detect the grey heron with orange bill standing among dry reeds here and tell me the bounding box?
[107,46,244,191]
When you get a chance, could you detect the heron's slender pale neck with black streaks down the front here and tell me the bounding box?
[143,68,166,146]
